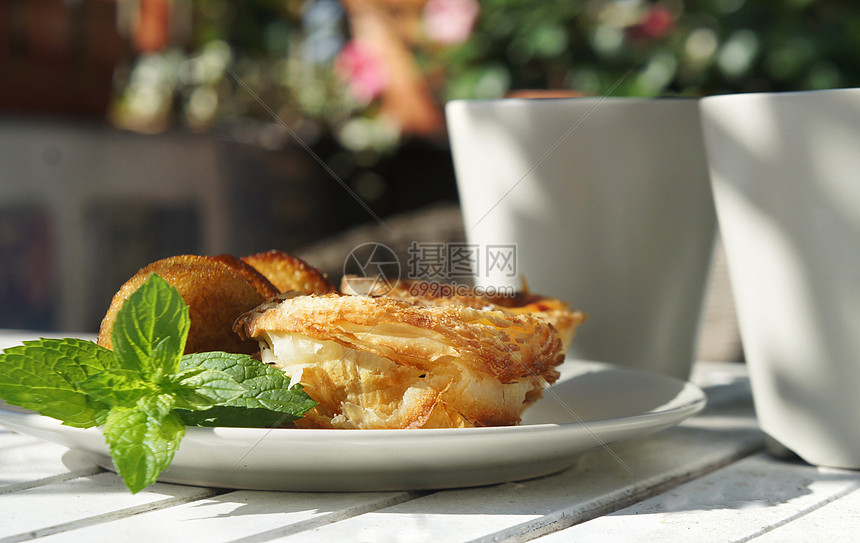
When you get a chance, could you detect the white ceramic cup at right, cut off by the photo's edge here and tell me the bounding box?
[701,89,860,468]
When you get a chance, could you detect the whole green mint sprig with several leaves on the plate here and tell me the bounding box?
[0,274,316,493]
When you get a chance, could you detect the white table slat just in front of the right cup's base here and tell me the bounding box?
[541,453,860,543]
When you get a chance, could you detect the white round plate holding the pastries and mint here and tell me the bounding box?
[0,360,706,491]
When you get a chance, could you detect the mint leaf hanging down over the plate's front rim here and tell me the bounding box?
[103,394,185,493]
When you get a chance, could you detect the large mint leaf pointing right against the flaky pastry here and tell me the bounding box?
[178,352,316,428]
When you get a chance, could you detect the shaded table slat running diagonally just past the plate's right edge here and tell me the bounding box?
[268,403,763,542]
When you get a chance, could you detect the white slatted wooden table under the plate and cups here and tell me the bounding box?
[0,333,860,543]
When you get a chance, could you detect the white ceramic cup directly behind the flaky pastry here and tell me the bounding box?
[446,98,715,378]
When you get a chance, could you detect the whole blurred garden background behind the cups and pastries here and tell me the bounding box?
[0,0,860,358]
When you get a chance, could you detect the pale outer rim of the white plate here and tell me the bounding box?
[0,359,707,491]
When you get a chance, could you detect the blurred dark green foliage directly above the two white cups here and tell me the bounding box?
[438,0,860,99]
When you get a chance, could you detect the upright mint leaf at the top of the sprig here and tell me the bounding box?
[111,274,191,377]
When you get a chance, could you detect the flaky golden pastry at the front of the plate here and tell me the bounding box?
[236,293,564,428]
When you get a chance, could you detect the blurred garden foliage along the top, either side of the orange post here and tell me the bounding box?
[114,0,860,151]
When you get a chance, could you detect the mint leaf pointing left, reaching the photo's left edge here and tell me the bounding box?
[0,339,117,428]
